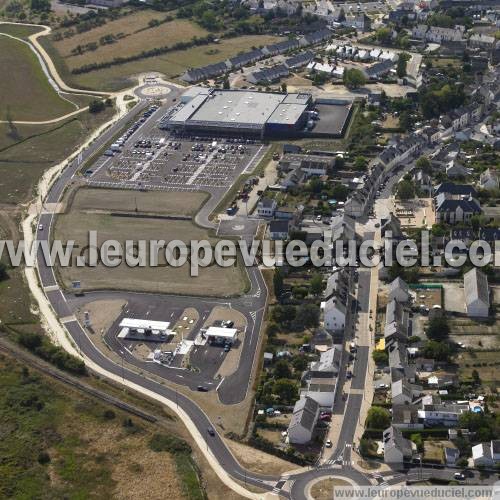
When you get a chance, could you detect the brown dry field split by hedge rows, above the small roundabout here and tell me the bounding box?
[54,15,207,69]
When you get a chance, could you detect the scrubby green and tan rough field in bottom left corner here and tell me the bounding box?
[0,355,203,499]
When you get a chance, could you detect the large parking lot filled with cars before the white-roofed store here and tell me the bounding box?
[85,104,266,191]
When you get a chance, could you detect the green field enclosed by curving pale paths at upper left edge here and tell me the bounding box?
[0,36,76,121]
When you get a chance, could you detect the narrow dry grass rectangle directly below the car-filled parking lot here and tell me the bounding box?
[71,188,208,215]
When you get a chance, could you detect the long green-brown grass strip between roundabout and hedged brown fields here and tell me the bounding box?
[41,35,280,91]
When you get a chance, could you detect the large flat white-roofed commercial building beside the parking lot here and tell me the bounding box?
[161,88,313,138]
